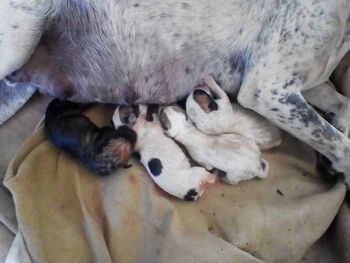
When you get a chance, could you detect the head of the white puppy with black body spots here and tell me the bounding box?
[112,105,140,128]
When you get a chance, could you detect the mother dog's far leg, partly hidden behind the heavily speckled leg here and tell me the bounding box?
[302,82,350,136]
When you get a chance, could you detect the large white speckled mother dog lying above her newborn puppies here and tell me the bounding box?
[0,0,350,185]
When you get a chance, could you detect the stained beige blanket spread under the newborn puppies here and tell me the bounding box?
[5,105,345,263]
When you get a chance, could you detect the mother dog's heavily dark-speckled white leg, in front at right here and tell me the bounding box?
[238,80,350,186]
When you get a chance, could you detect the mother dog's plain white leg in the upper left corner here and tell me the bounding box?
[0,0,52,79]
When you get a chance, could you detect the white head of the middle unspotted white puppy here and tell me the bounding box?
[159,105,190,137]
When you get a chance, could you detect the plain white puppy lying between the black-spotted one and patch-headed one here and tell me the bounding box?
[160,106,269,184]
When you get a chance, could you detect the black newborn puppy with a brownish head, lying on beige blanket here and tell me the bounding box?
[45,99,136,175]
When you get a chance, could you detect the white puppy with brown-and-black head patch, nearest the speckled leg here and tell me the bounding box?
[186,76,281,150]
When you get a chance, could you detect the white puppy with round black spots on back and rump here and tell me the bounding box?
[113,105,215,201]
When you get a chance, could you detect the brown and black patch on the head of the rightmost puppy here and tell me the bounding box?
[190,86,219,113]
